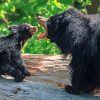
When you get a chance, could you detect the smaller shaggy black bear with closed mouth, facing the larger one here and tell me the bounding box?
[0,24,36,82]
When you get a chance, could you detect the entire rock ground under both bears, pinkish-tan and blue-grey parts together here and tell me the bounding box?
[0,54,100,100]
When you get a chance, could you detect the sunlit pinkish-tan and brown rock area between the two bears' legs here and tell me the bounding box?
[22,54,70,87]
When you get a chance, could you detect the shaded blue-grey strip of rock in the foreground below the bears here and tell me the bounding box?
[0,79,100,100]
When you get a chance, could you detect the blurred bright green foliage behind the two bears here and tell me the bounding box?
[0,0,100,54]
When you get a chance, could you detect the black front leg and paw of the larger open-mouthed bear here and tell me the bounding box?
[65,56,94,94]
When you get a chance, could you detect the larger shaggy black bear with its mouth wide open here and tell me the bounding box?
[37,8,100,94]
